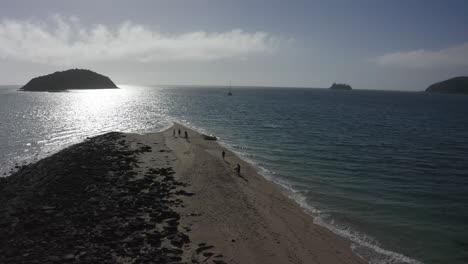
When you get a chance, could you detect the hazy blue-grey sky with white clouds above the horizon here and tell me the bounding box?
[0,0,468,91]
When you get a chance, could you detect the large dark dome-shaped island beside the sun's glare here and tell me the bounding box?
[20,69,119,92]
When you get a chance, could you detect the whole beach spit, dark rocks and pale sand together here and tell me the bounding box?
[0,124,365,263]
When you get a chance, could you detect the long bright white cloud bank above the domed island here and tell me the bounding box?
[0,15,279,65]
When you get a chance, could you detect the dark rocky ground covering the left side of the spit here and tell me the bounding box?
[0,133,199,263]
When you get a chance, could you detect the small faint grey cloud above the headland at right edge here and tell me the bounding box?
[376,43,468,69]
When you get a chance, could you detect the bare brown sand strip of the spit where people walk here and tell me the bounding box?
[136,124,365,263]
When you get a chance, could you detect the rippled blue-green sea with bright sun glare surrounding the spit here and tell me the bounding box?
[0,85,468,264]
